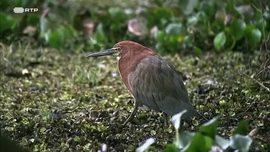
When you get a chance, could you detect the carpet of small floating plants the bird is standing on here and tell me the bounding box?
[0,45,270,151]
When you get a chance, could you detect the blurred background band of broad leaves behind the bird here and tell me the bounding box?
[0,0,270,54]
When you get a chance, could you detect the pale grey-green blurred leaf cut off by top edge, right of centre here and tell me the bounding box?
[179,0,199,15]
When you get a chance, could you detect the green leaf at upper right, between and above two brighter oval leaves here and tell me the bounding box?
[230,19,246,40]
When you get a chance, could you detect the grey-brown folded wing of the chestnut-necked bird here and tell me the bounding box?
[128,55,198,119]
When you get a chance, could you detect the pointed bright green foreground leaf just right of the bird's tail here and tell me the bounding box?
[199,117,219,139]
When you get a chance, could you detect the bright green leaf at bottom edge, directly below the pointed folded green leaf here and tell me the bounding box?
[183,132,213,152]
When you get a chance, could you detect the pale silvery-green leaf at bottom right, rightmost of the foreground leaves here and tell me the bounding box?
[231,134,252,152]
